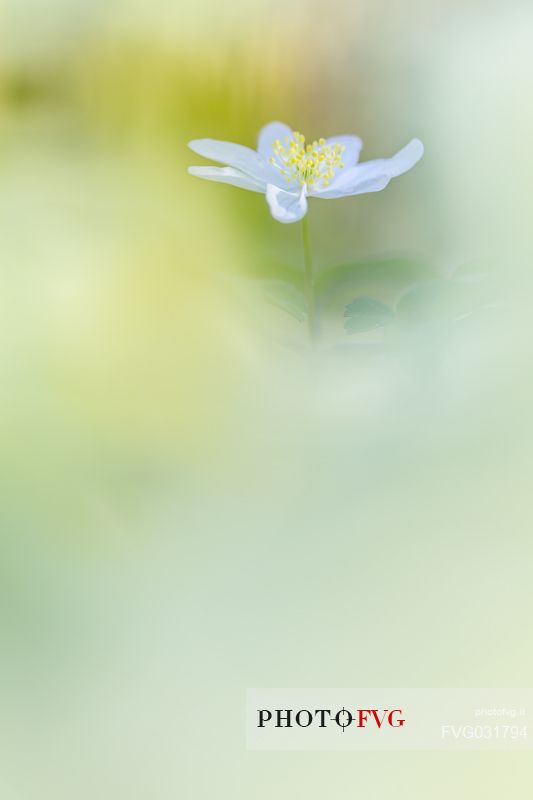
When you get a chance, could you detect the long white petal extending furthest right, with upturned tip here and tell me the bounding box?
[313,139,424,199]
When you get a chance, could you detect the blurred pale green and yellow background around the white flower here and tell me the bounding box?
[0,0,533,800]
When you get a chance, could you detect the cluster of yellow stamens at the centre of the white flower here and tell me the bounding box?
[270,131,345,186]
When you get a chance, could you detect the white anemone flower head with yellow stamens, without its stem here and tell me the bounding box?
[189,122,424,222]
